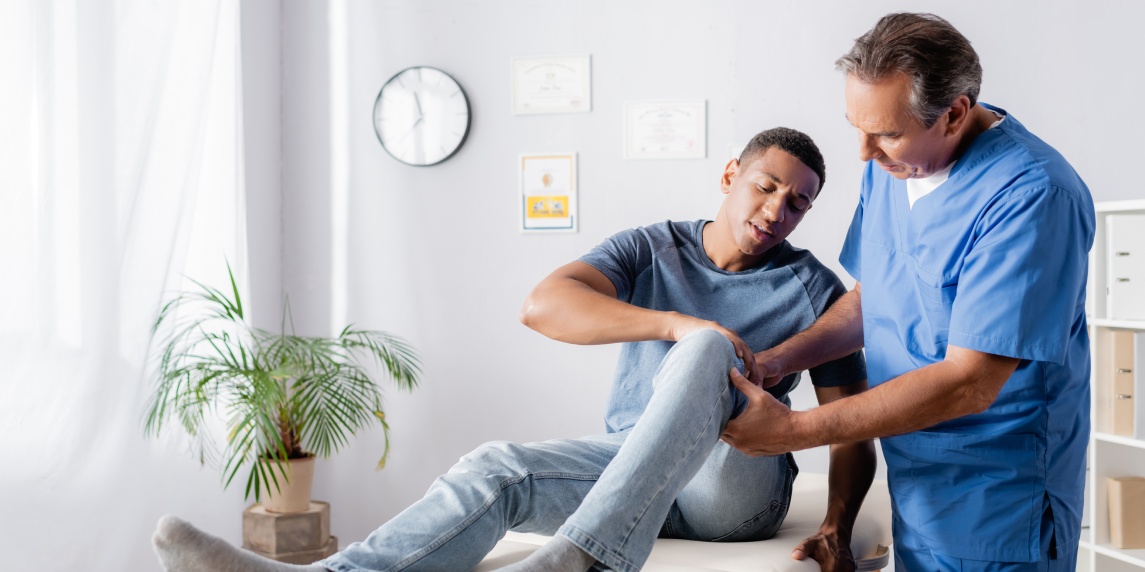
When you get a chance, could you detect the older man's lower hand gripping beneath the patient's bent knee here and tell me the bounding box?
[720,370,804,456]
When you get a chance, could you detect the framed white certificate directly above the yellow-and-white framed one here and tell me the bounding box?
[513,56,592,114]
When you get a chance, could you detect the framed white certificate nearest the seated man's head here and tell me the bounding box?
[624,100,708,159]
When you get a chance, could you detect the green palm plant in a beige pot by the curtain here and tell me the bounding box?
[144,264,420,513]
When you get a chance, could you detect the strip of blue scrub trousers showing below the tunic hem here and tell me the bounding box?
[893,510,1077,572]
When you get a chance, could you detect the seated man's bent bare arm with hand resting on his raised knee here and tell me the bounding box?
[521,261,755,379]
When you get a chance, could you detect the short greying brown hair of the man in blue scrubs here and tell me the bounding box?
[835,13,982,127]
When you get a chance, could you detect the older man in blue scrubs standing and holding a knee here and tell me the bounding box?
[724,14,1095,571]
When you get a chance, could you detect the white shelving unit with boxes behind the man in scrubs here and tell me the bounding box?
[1077,200,1145,572]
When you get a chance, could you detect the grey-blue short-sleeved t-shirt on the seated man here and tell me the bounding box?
[581,221,867,432]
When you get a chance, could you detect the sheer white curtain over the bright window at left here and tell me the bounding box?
[0,0,246,571]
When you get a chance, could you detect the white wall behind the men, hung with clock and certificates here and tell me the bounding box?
[246,0,1145,546]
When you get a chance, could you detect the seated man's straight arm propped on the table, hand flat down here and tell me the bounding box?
[791,380,877,571]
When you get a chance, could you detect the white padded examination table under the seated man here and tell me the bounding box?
[474,472,891,572]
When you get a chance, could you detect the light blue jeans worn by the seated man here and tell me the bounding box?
[319,329,797,572]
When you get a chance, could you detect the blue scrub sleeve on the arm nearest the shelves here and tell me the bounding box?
[948,186,1093,364]
